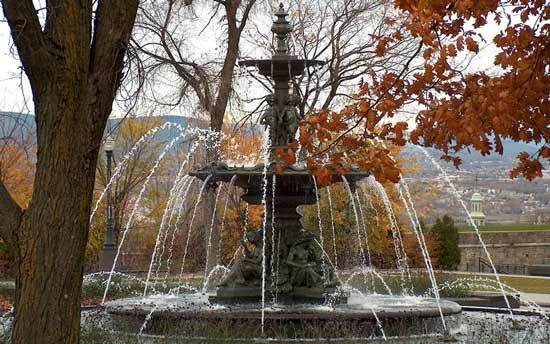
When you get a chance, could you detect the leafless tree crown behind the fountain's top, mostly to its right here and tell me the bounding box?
[246,0,415,116]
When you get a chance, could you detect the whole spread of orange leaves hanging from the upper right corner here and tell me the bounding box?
[292,0,550,181]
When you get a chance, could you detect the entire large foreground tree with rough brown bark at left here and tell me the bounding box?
[0,0,138,344]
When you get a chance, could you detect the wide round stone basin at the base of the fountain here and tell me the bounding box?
[105,294,461,339]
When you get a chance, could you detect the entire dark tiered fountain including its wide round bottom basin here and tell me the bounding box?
[101,4,461,338]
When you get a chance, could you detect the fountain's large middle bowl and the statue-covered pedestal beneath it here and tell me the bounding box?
[191,164,368,303]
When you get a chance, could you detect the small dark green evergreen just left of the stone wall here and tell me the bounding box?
[432,215,460,270]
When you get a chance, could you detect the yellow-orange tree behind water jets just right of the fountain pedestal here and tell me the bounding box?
[302,183,409,269]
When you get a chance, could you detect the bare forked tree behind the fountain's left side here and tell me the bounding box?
[133,0,256,271]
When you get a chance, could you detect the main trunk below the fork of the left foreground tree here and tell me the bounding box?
[13,106,101,343]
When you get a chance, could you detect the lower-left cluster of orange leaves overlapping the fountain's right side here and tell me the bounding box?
[277,92,407,185]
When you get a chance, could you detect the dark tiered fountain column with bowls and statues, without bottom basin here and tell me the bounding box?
[191,4,368,302]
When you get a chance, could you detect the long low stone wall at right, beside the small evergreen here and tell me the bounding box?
[459,231,550,274]
